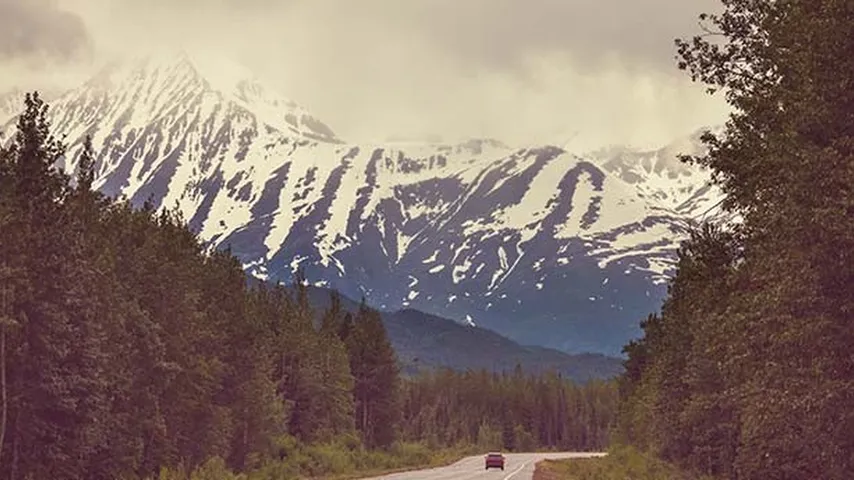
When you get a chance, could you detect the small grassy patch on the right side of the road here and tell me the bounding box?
[534,447,714,480]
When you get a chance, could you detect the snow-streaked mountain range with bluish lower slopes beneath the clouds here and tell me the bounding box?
[0,54,718,354]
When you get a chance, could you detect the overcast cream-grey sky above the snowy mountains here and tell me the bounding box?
[0,0,727,147]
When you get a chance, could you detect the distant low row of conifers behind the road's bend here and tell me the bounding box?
[401,368,617,451]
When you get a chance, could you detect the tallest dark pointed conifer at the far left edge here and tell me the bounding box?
[0,94,110,478]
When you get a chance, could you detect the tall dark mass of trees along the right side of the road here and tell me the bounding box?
[619,0,854,480]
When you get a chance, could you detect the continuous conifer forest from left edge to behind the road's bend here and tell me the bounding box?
[0,94,615,480]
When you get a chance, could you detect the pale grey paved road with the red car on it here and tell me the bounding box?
[364,452,604,480]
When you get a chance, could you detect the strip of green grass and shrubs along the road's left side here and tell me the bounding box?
[152,442,477,480]
